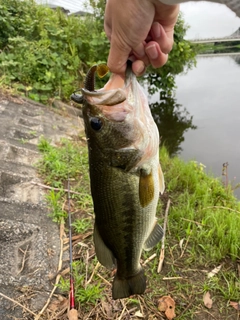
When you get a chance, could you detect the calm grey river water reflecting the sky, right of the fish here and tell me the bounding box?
[154,55,240,198]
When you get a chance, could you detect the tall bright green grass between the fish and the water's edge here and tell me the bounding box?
[161,149,240,264]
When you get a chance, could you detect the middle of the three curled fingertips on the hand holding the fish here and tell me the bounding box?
[145,41,168,68]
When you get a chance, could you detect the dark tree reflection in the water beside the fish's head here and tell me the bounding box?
[150,93,197,156]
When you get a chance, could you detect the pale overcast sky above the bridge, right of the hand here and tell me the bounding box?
[180,1,240,39]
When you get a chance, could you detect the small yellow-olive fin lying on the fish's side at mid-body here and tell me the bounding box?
[139,169,154,208]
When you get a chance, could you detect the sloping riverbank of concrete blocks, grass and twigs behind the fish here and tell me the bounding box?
[0,89,240,320]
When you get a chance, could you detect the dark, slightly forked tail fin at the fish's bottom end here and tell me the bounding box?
[112,269,146,299]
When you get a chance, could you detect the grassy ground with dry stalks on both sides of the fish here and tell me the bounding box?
[38,138,240,320]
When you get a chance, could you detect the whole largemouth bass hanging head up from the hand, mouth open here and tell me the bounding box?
[73,66,164,299]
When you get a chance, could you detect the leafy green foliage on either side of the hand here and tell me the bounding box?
[0,0,195,102]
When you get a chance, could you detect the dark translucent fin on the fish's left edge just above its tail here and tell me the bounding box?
[93,223,115,269]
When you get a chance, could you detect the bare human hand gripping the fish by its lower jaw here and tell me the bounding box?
[105,0,179,75]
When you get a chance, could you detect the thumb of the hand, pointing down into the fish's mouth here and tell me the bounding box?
[107,36,131,74]
